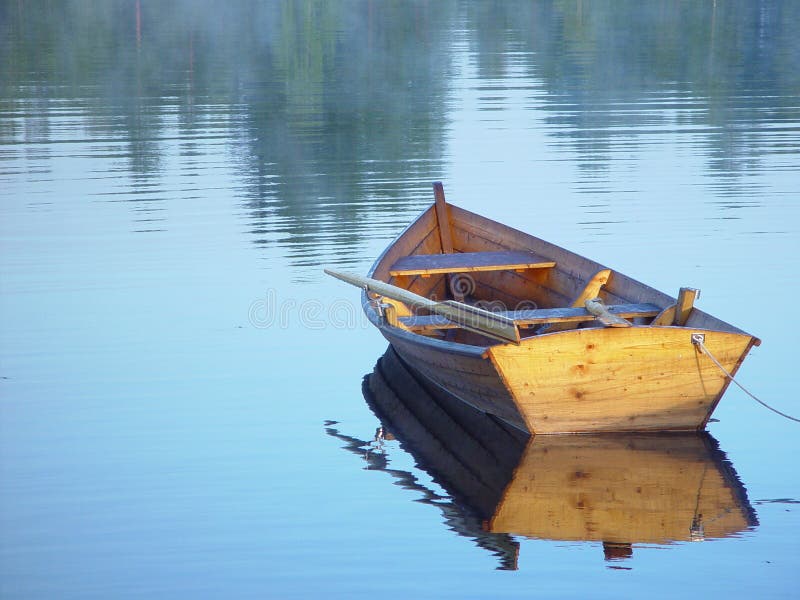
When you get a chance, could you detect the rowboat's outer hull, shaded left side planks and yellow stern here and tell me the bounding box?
[381,327,753,434]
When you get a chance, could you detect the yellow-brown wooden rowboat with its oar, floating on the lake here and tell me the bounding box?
[328,183,760,434]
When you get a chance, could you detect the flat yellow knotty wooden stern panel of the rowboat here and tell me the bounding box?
[489,327,753,434]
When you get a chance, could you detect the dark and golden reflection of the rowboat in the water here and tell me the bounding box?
[328,347,758,569]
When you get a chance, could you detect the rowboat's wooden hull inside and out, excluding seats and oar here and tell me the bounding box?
[362,199,760,434]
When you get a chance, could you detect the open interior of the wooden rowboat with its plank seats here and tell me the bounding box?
[371,183,738,346]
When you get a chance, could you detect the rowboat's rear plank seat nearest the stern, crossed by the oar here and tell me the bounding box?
[399,304,661,331]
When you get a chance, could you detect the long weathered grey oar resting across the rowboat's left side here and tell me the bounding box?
[325,269,520,344]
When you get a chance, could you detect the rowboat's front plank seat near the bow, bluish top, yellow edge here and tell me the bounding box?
[389,250,556,277]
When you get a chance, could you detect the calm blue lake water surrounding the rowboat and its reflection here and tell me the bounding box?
[0,0,800,599]
